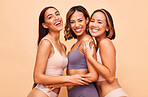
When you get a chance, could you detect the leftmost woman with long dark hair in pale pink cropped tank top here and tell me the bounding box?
[27,6,90,97]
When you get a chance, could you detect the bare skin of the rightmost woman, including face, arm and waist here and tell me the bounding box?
[84,12,121,97]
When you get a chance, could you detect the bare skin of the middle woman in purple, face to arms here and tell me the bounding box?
[48,11,98,90]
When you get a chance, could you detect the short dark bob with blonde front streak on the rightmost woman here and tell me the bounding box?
[91,8,115,40]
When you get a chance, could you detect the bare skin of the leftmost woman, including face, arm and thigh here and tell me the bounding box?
[27,8,89,97]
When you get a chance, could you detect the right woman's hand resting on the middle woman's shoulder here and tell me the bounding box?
[83,39,94,58]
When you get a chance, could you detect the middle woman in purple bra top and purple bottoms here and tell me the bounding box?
[44,5,99,97]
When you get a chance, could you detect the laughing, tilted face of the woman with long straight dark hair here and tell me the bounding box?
[42,8,63,32]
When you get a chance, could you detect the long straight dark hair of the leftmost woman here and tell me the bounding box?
[38,6,57,45]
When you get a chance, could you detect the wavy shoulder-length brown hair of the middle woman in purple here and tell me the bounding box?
[64,5,90,40]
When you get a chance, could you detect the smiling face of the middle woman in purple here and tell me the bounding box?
[70,11,88,37]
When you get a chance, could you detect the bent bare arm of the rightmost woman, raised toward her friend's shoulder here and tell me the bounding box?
[85,39,116,83]
